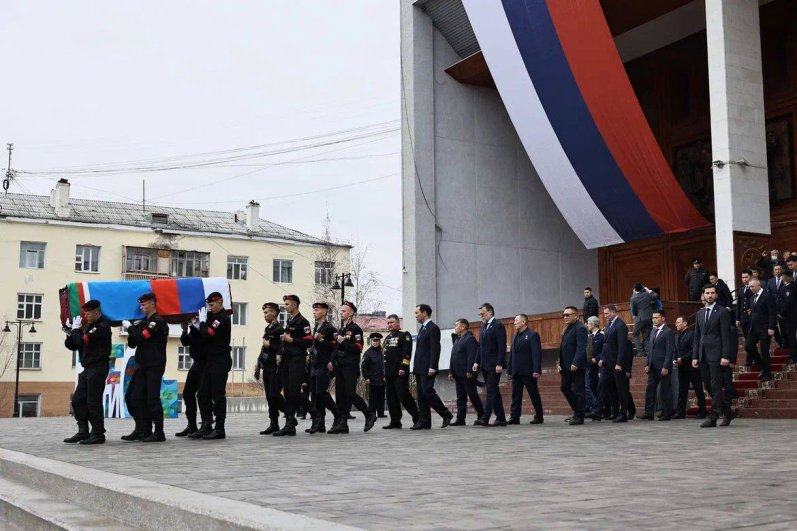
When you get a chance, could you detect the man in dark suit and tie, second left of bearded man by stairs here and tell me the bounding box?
[639,310,675,420]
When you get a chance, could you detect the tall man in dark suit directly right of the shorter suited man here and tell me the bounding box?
[473,302,506,426]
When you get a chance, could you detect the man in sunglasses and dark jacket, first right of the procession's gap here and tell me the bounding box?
[557,306,587,426]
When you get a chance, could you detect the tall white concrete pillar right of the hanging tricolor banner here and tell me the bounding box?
[706,0,770,289]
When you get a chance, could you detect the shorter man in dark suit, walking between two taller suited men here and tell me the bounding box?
[448,319,484,426]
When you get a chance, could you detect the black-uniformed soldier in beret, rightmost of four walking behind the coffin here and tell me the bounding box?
[328,301,376,434]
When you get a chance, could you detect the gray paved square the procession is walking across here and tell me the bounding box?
[0,414,797,529]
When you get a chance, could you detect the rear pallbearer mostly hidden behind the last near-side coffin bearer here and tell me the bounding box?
[174,319,213,437]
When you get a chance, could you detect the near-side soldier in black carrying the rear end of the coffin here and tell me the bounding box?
[189,291,232,440]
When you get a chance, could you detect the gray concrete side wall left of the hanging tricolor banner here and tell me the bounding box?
[402,3,598,330]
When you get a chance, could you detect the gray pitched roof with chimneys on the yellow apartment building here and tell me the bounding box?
[0,179,350,247]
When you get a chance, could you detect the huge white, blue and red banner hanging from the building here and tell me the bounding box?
[463,0,709,248]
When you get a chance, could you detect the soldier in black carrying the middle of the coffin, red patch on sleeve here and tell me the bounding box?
[122,293,169,442]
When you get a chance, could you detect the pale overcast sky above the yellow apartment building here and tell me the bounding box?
[0,0,401,311]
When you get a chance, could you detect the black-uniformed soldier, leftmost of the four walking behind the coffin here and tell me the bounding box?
[255,302,285,435]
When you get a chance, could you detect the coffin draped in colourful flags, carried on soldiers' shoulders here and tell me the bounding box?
[59,278,232,323]
